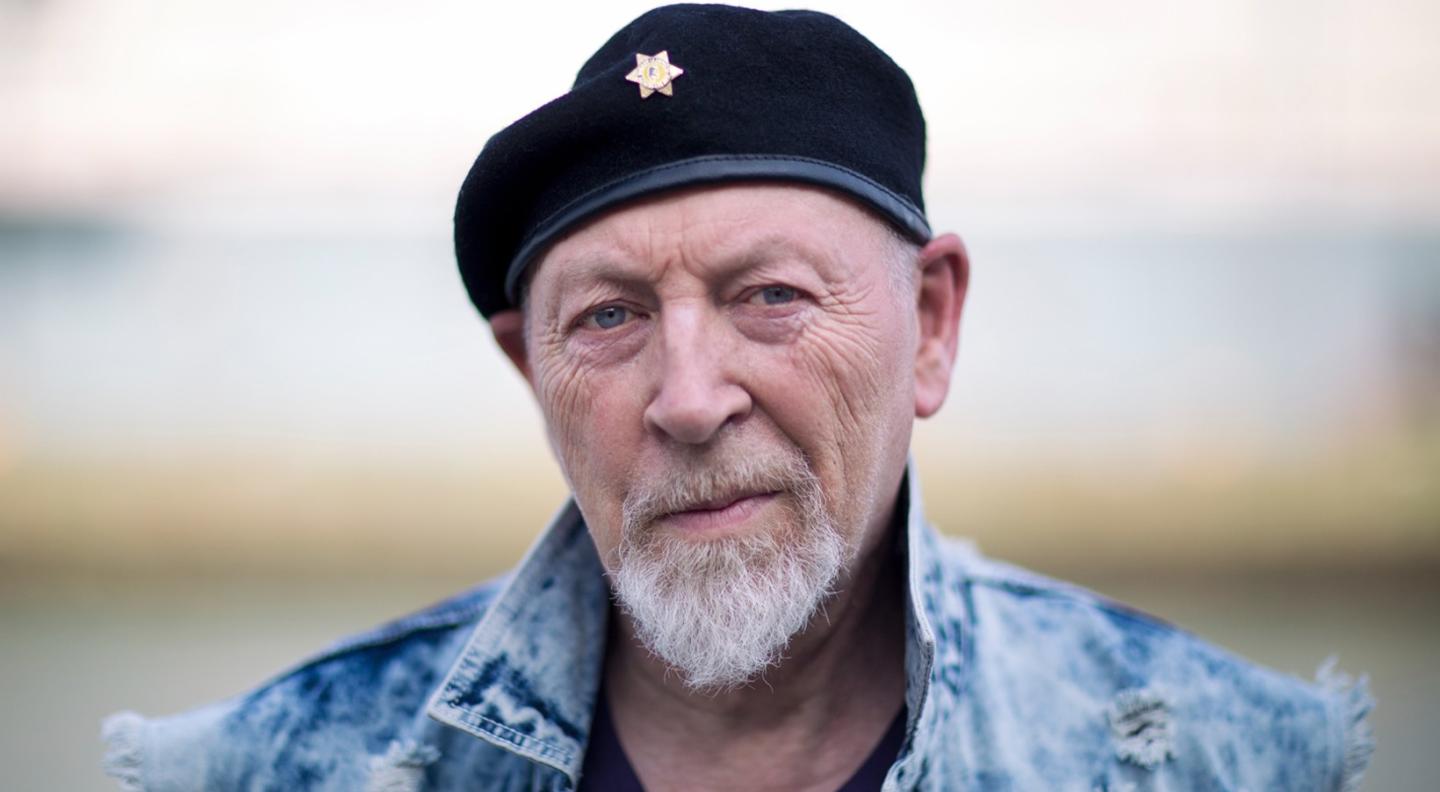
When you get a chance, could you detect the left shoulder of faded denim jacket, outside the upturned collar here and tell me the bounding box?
[101,576,529,792]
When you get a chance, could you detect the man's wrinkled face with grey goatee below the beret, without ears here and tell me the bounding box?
[524,184,917,688]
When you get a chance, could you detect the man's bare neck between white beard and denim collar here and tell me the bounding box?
[605,504,906,791]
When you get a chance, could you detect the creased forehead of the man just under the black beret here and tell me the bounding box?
[530,184,890,298]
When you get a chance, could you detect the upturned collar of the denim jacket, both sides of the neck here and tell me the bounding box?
[426,459,963,785]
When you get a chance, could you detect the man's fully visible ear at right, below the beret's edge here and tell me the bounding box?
[914,233,971,418]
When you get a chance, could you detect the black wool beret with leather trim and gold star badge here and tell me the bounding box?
[455,4,930,318]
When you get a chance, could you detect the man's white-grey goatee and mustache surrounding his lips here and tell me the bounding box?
[612,449,850,693]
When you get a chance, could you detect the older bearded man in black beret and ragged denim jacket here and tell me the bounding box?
[107,6,1369,792]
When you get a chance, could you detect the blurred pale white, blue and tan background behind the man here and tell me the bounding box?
[0,0,1440,791]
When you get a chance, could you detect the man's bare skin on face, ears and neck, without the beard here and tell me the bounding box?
[491,184,969,791]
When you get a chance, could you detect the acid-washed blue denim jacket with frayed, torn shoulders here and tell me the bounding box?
[102,465,1371,792]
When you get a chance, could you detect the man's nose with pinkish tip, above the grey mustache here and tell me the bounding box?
[645,308,752,445]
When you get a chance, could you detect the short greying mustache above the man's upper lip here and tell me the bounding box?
[621,446,819,536]
